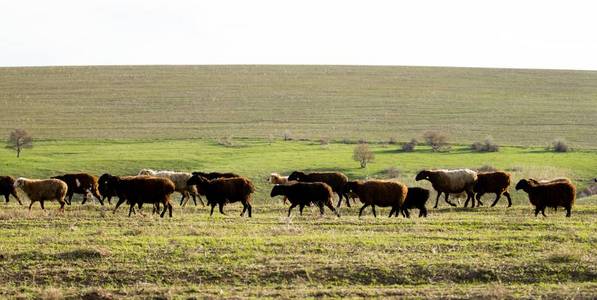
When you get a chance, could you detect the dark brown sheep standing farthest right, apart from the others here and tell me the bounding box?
[516,179,576,217]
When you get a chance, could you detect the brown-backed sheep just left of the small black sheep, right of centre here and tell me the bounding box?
[345,180,408,218]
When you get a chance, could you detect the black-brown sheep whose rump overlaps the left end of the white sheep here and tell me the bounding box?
[105,174,175,218]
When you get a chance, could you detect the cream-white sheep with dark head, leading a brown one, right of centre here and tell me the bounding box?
[415,169,474,208]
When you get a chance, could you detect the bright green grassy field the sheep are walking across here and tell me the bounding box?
[0,139,597,298]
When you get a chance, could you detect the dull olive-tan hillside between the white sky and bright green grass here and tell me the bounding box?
[0,66,597,148]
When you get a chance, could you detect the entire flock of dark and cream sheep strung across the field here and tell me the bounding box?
[0,169,576,217]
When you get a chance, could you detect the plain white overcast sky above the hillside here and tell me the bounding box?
[0,0,597,70]
